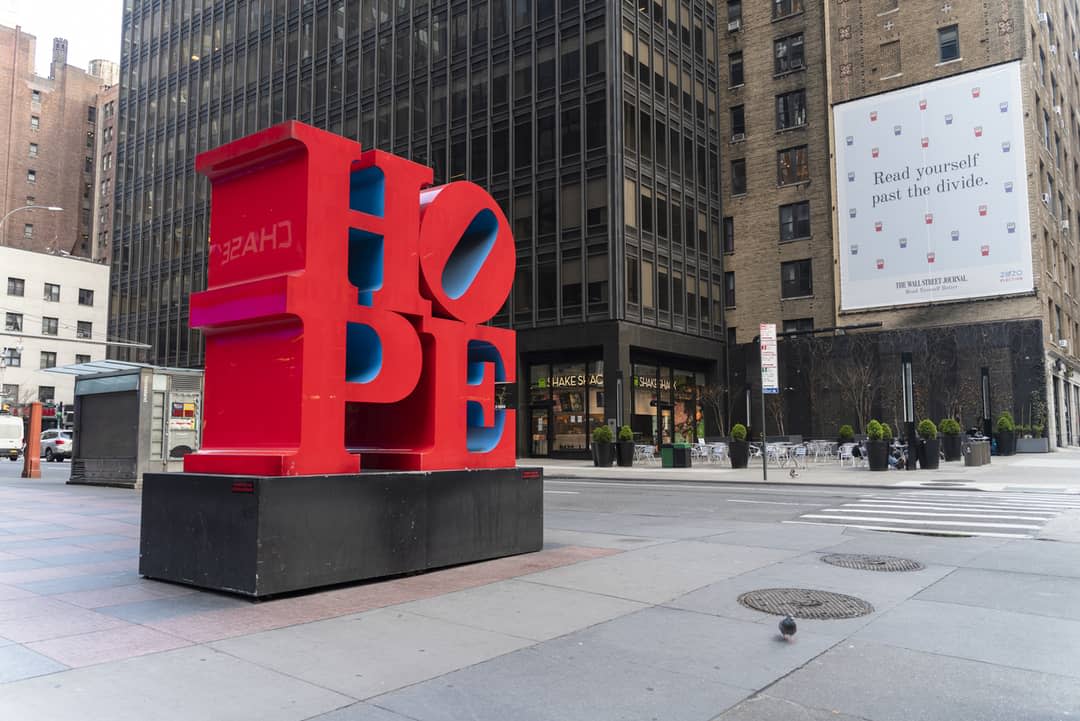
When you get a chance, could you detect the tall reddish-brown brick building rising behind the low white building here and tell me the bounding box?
[0,26,116,256]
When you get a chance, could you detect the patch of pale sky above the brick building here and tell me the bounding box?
[0,0,123,76]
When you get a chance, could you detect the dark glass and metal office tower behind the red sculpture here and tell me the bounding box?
[110,0,725,452]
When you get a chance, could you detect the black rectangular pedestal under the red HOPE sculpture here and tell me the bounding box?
[139,468,543,598]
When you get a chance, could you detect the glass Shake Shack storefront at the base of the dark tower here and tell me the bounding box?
[517,324,723,459]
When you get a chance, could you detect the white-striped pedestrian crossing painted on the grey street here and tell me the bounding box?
[784,490,1080,539]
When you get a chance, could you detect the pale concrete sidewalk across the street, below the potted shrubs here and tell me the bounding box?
[517,449,1080,492]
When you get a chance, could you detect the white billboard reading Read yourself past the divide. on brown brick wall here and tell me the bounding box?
[833,63,1034,310]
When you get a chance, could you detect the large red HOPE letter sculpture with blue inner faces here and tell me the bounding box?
[184,122,515,476]
